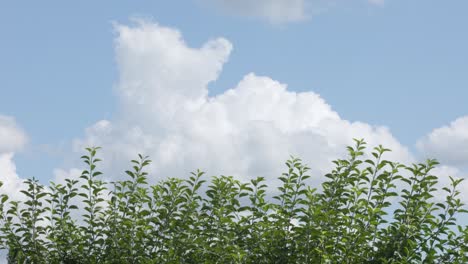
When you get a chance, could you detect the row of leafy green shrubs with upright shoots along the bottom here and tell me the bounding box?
[0,140,468,263]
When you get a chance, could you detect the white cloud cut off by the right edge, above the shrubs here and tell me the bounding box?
[416,116,468,166]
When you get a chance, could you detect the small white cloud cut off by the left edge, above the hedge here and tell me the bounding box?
[0,115,27,199]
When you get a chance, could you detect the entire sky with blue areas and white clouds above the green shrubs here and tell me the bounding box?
[0,0,468,201]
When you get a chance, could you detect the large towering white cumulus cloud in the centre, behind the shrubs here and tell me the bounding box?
[67,21,412,189]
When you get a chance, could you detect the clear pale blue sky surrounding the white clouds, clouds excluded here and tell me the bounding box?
[0,0,468,188]
